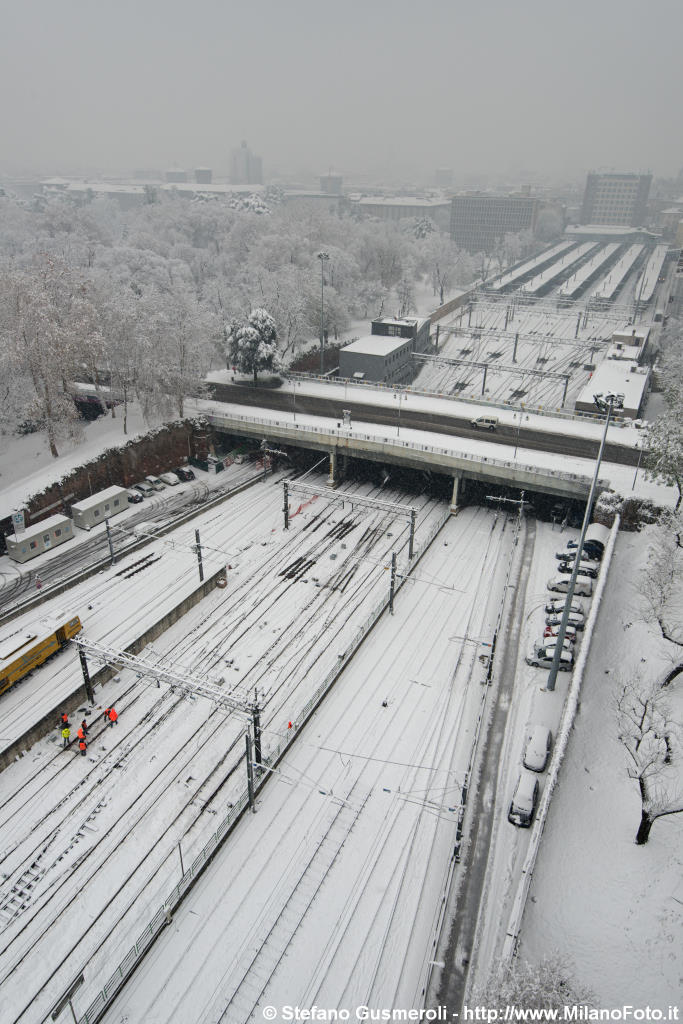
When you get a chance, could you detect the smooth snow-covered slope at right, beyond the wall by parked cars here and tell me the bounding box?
[521,535,683,1012]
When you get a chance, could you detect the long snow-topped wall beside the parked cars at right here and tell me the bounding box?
[501,515,621,965]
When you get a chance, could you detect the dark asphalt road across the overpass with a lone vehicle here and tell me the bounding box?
[211,384,639,466]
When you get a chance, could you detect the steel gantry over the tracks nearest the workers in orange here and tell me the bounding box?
[72,636,261,811]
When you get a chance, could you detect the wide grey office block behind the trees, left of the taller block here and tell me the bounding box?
[451,193,539,253]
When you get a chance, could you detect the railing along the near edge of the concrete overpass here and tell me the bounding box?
[206,409,609,489]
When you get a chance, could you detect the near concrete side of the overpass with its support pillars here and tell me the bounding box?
[207,407,608,510]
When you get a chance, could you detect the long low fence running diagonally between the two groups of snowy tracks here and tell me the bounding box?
[78,511,451,1024]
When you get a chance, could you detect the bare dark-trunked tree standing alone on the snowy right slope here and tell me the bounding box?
[614,678,683,846]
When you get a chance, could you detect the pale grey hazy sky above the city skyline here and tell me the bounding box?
[0,0,683,180]
